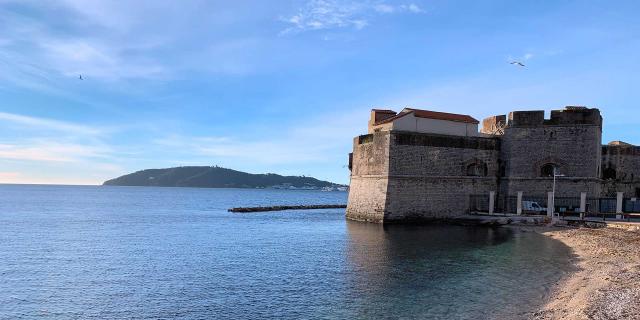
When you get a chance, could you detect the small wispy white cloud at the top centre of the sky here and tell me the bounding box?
[280,0,424,34]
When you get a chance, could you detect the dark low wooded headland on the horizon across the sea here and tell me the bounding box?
[103,166,347,191]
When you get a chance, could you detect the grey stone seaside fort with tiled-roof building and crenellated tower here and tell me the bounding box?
[347,106,640,223]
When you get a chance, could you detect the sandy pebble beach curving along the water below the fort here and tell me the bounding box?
[533,227,640,319]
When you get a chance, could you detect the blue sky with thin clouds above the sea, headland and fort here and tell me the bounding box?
[0,0,640,184]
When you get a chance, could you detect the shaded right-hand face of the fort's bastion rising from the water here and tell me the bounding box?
[385,132,500,222]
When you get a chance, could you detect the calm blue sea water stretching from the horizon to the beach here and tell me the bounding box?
[0,185,570,319]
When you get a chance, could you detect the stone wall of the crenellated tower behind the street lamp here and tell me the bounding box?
[501,124,602,197]
